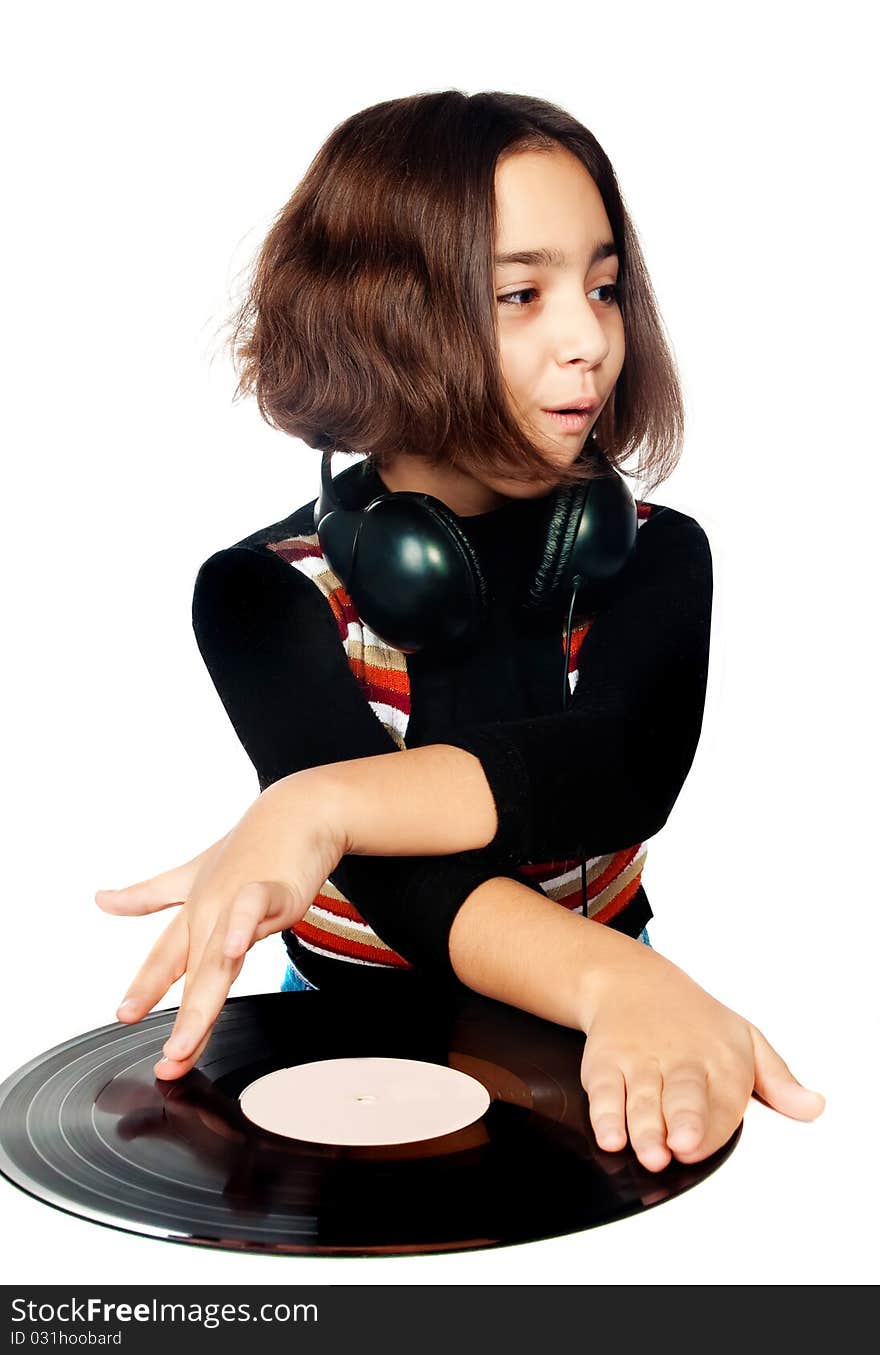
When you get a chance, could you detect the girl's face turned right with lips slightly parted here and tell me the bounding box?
[484,146,624,497]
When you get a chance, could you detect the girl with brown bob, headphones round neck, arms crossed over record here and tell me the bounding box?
[96,91,823,1169]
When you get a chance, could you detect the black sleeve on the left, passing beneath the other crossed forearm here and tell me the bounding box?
[193,547,545,974]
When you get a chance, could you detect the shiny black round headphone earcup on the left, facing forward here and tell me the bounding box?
[317,491,488,653]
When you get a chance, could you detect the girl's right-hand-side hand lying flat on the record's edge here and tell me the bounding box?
[580,950,824,1171]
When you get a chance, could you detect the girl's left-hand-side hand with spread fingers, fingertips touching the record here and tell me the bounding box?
[95,768,348,1079]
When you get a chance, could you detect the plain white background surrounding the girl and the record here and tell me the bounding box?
[0,0,879,1285]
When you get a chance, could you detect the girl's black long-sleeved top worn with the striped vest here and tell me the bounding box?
[193,461,712,989]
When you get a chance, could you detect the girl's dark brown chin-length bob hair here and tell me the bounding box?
[229,89,685,488]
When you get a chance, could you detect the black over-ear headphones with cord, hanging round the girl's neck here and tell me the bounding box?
[315,449,637,917]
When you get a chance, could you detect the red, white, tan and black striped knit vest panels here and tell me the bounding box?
[268,501,651,969]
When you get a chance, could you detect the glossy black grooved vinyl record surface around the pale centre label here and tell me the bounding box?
[0,991,742,1256]
